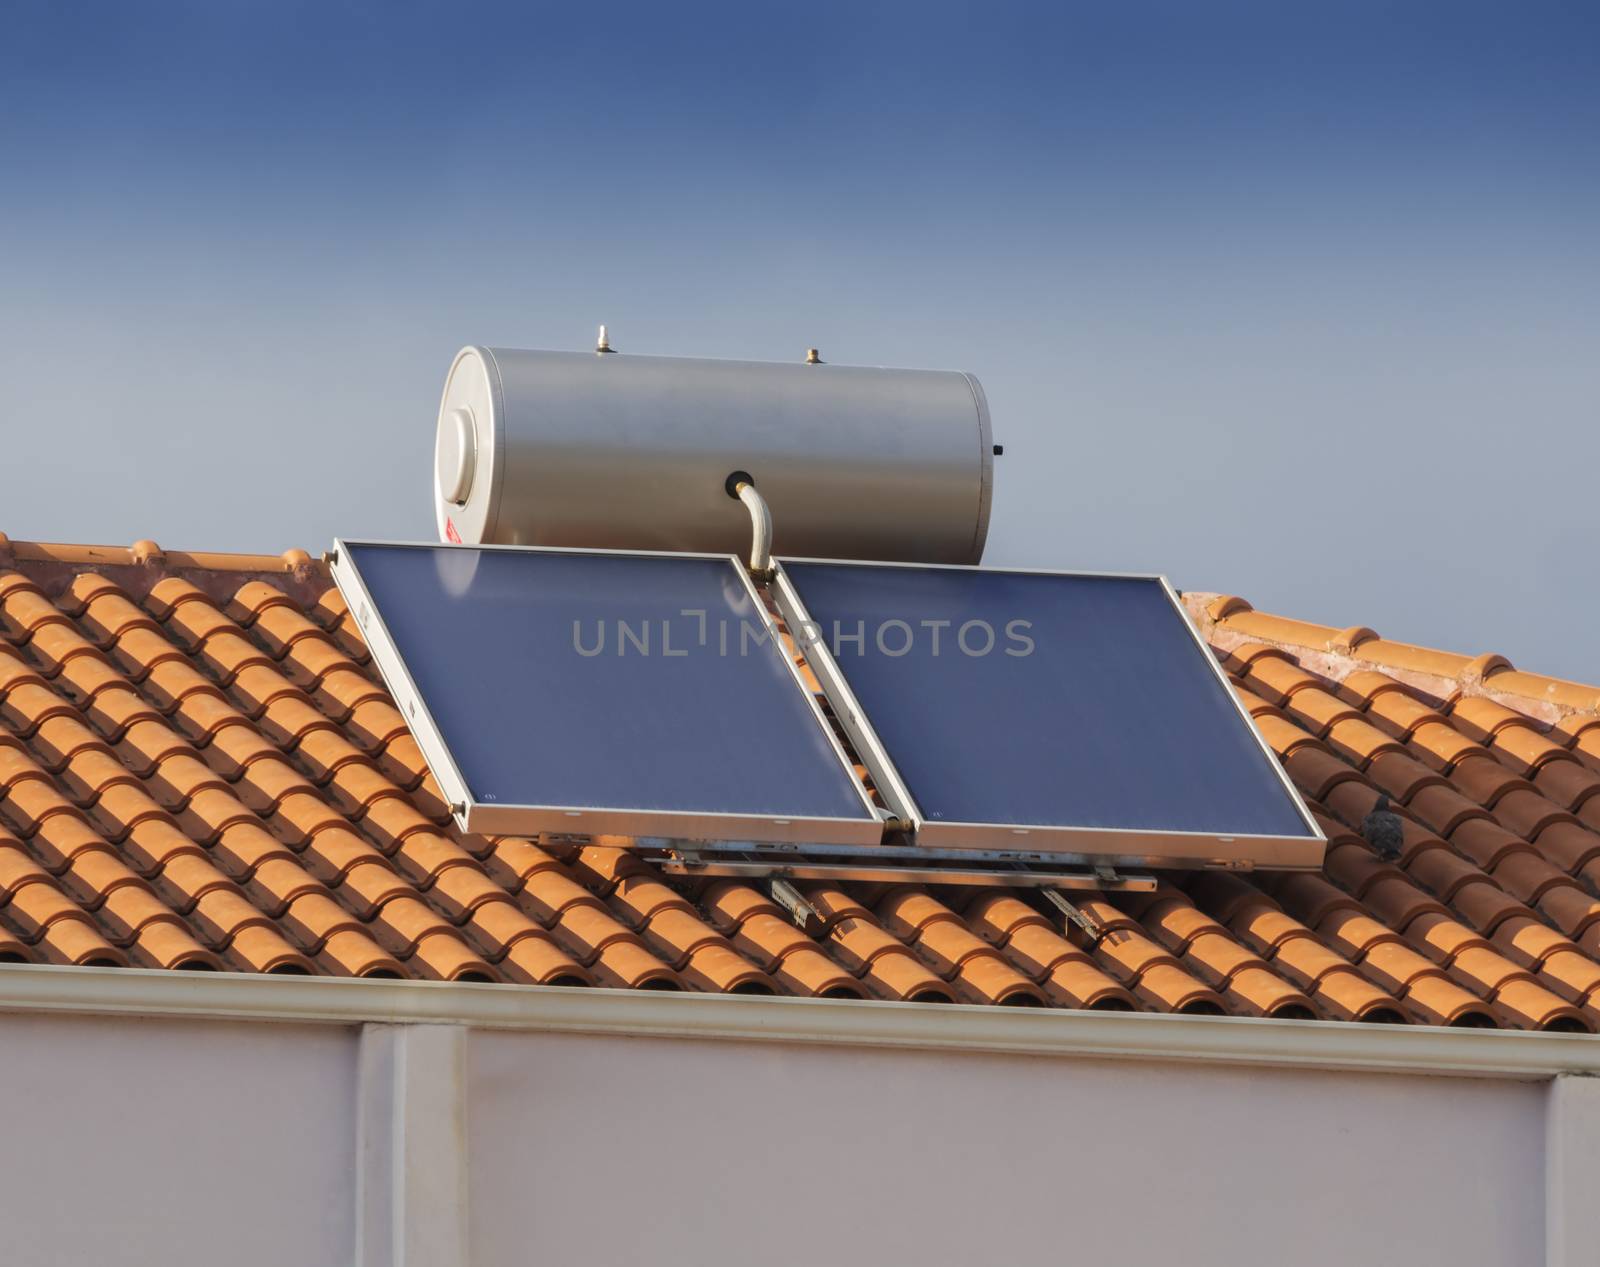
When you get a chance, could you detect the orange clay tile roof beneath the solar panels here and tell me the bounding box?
[0,536,1600,1030]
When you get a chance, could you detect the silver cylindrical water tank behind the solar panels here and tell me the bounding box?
[434,347,994,563]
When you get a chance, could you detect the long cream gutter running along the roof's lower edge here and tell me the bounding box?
[0,965,1600,1080]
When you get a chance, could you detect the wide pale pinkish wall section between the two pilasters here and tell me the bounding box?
[467,1032,1546,1267]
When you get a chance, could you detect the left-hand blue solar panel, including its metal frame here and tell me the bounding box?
[333,541,882,845]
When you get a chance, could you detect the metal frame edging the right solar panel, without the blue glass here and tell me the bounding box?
[771,558,1326,870]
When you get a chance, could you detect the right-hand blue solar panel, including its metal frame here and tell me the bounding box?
[774,560,1323,865]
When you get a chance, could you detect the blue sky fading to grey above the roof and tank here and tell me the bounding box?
[0,2,1600,681]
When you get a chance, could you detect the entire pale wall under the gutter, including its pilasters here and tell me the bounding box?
[0,1014,1561,1267]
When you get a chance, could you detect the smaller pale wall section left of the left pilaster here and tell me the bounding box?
[0,1016,355,1267]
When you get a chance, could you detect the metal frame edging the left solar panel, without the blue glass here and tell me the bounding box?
[331,539,883,848]
